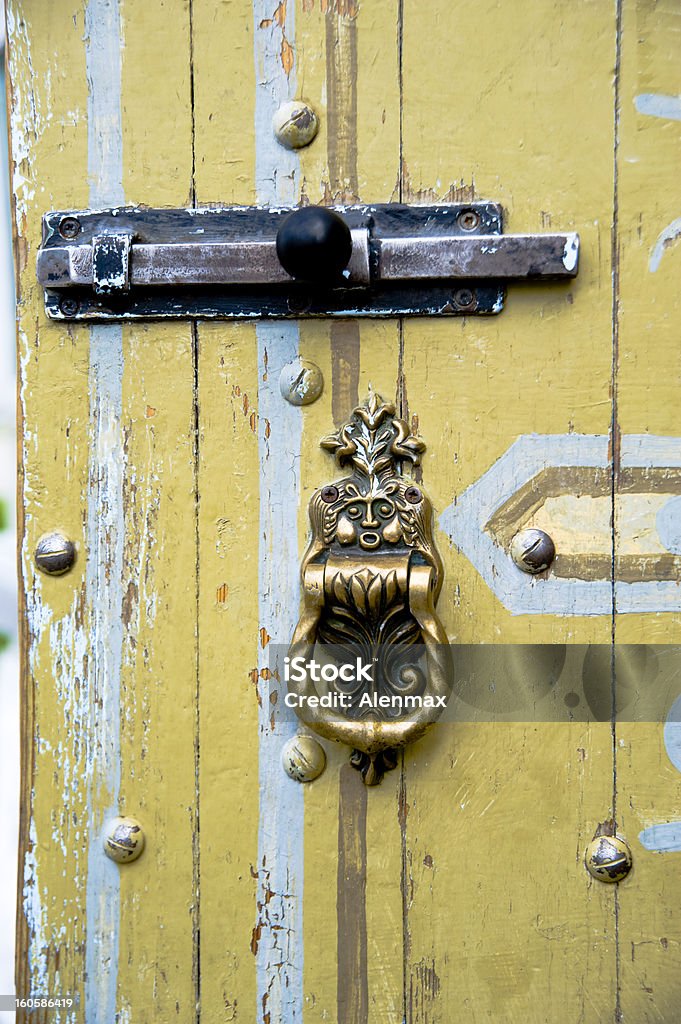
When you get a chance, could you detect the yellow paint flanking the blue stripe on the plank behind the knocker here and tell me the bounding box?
[189,2,402,1021]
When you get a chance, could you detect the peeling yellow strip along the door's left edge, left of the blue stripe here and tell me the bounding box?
[7,4,93,1015]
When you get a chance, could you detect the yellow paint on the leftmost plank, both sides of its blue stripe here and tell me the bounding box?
[8,0,196,1021]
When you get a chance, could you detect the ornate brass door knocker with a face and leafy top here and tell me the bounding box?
[288,394,452,784]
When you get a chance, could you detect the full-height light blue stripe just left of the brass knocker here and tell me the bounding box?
[253,0,304,1024]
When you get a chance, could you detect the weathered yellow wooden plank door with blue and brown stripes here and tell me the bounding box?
[7,0,681,1024]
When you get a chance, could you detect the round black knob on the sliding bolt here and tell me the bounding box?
[276,206,352,284]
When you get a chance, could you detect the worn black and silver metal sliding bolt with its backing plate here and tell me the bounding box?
[37,203,579,322]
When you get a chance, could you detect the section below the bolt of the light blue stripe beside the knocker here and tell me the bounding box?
[256,324,304,1024]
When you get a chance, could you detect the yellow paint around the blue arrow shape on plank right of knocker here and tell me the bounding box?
[403,2,615,1024]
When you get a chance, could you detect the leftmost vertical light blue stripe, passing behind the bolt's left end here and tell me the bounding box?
[85,0,125,1024]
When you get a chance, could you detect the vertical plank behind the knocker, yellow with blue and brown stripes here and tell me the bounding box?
[194,0,401,1020]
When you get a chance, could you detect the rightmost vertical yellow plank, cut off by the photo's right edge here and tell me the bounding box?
[614,0,681,1021]
